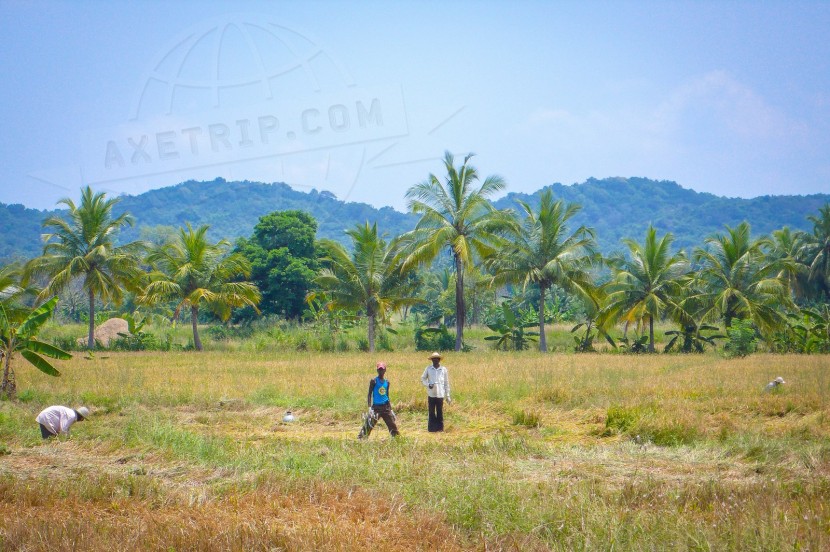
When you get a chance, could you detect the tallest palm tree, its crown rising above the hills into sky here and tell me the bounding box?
[403,152,512,351]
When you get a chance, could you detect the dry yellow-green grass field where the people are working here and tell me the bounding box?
[0,351,830,551]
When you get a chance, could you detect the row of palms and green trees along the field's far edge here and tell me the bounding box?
[0,152,830,396]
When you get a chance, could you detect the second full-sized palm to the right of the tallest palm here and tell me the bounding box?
[604,226,689,353]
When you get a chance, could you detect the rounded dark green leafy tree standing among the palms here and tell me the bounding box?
[236,211,320,318]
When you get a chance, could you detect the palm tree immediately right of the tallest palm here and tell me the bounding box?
[487,189,596,351]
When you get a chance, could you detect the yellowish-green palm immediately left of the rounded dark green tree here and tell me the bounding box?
[138,224,260,351]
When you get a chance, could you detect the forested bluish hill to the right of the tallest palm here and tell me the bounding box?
[495,178,830,254]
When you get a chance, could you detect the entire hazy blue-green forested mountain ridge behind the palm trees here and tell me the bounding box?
[0,177,830,262]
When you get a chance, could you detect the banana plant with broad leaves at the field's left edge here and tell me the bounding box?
[0,297,72,399]
